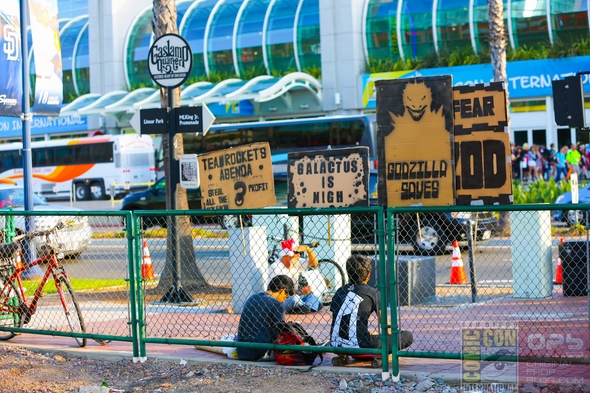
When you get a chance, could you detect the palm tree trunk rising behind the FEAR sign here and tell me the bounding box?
[488,0,512,233]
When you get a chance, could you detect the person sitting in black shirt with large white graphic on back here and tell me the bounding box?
[330,254,414,353]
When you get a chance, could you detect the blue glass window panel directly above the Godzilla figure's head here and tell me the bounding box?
[400,0,434,58]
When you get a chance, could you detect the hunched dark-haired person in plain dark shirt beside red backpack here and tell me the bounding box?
[237,275,295,361]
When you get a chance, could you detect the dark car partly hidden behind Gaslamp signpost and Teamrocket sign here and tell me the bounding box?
[121,178,251,229]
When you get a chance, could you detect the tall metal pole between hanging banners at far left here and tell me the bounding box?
[20,1,43,279]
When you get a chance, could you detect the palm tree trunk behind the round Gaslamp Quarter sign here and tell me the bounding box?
[152,0,208,291]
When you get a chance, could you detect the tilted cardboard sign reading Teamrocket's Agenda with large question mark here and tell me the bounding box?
[198,142,276,210]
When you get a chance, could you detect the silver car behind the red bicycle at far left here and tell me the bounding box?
[0,185,93,256]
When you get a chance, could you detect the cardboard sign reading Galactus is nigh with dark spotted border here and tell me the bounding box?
[288,147,369,209]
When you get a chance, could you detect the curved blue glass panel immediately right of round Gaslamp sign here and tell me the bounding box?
[180,0,217,84]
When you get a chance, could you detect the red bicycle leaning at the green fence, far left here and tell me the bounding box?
[0,222,86,347]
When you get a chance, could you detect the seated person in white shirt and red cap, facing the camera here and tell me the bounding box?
[269,239,322,314]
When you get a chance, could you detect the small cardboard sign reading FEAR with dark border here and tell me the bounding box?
[453,82,508,136]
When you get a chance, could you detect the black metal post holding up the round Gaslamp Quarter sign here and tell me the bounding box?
[162,87,193,303]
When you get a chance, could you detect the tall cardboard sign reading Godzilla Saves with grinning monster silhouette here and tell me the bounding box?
[375,75,455,206]
